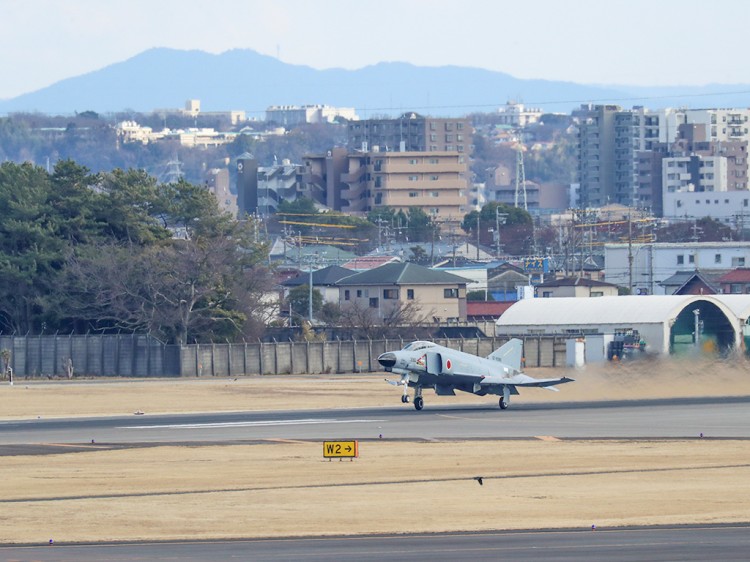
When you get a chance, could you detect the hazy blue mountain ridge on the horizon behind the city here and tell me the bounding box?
[0,48,750,118]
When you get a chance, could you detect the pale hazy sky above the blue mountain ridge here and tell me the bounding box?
[0,0,750,99]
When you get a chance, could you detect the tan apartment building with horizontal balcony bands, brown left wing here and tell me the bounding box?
[341,149,469,222]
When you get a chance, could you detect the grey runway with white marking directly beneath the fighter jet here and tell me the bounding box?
[0,397,750,446]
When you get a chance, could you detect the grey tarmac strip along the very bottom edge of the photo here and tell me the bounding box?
[0,525,750,562]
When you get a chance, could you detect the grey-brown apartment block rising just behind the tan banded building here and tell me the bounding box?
[348,112,473,155]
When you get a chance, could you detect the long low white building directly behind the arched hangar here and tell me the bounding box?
[604,241,750,295]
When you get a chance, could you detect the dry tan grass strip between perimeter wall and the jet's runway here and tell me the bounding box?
[0,360,750,419]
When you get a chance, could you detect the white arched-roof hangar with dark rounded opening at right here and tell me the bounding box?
[495,295,750,355]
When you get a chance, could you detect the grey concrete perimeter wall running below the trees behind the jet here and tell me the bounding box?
[0,335,565,377]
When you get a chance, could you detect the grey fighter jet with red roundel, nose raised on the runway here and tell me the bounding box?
[378,338,574,410]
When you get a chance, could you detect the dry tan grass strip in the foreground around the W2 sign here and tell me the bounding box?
[0,440,750,542]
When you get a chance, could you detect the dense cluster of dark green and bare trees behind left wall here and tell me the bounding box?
[0,160,271,343]
